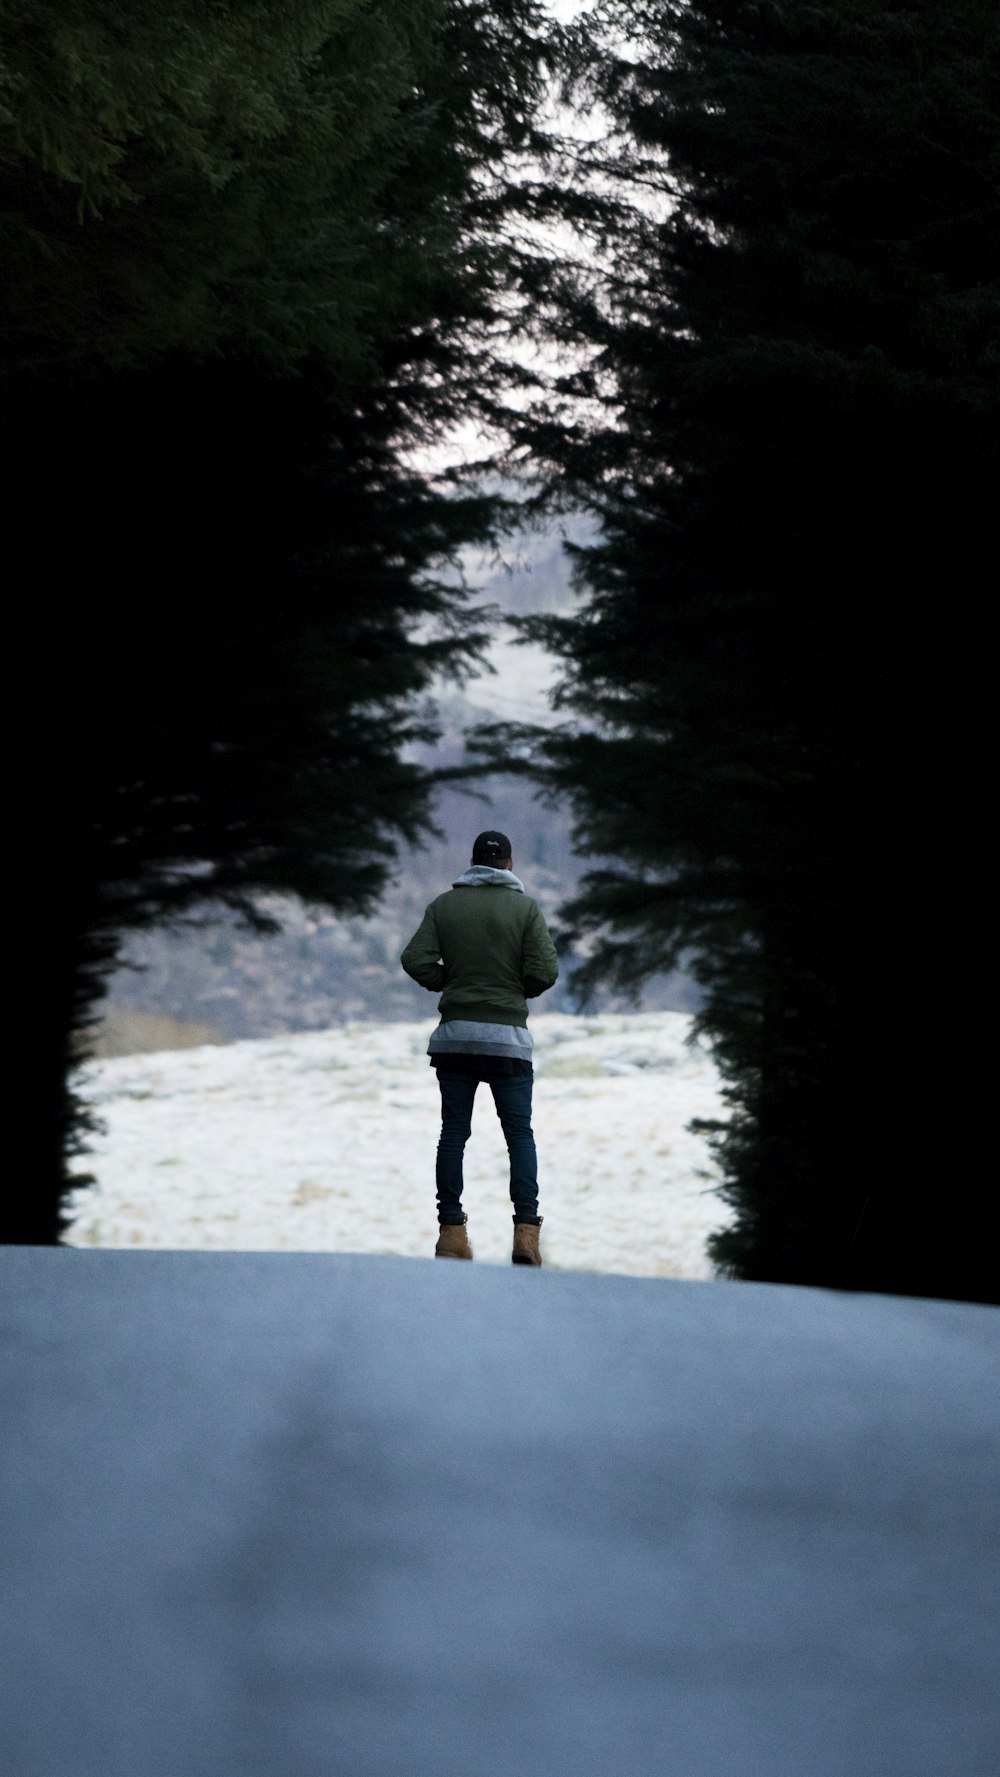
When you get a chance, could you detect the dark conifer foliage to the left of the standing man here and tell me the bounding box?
[0,0,544,1242]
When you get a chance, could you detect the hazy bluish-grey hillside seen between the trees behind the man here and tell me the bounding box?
[94,521,698,1056]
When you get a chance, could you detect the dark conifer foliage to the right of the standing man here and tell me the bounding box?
[507,0,1000,1299]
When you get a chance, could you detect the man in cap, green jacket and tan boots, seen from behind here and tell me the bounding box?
[401,832,560,1265]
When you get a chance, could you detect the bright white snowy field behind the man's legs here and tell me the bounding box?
[66,1013,728,1278]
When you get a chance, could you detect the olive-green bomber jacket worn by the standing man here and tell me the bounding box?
[400,865,560,1024]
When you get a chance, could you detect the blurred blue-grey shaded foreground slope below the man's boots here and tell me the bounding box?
[0,1249,1000,1777]
